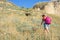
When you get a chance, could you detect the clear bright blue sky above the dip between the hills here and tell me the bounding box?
[9,0,49,8]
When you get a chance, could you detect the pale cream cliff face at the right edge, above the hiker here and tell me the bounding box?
[45,2,60,14]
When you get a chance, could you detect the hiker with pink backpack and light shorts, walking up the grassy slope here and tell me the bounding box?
[41,14,51,35]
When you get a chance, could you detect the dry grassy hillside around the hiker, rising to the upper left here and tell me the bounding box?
[0,1,60,40]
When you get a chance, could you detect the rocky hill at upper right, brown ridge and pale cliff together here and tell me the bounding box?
[33,1,60,16]
